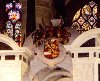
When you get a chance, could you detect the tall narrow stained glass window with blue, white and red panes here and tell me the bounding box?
[6,1,22,46]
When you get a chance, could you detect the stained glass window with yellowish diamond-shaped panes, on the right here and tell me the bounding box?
[72,1,97,33]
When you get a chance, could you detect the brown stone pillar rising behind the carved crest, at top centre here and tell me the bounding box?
[35,0,50,28]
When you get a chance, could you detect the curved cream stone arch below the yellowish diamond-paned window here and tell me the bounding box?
[71,28,100,48]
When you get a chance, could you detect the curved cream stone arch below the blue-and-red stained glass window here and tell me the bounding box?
[0,34,19,50]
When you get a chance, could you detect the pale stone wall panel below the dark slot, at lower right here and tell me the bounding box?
[73,58,94,81]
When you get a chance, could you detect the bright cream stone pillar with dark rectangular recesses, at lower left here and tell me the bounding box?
[0,48,32,81]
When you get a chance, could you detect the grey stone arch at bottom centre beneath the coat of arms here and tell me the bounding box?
[31,67,72,81]
